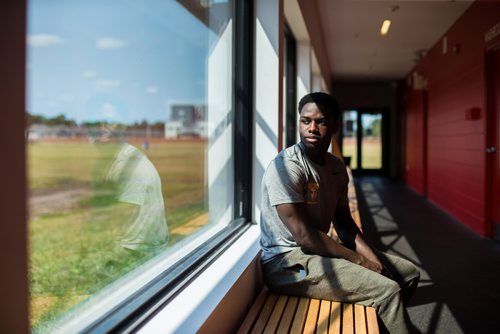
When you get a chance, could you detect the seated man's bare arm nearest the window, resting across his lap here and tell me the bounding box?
[276,203,383,273]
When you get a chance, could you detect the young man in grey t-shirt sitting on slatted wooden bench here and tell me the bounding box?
[261,93,420,333]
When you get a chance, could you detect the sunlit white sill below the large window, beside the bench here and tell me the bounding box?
[139,225,260,334]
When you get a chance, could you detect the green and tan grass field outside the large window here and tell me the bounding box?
[28,141,207,331]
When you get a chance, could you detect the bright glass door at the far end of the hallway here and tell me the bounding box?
[342,110,384,173]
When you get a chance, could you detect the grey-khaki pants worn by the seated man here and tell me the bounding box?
[262,248,420,334]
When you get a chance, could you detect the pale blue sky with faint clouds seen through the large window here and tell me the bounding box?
[27,0,222,124]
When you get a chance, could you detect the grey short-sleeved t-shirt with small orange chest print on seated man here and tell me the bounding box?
[260,143,349,263]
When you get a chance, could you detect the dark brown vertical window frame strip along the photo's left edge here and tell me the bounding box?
[0,0,30,333]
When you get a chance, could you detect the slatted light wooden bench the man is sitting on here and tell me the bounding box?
[238,169,379,334]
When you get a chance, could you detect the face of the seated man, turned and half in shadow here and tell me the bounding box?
[299,102,338,151]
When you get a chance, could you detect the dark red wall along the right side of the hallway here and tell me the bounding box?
[405,1,500,235]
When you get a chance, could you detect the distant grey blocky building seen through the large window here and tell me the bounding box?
[165,104,208,139]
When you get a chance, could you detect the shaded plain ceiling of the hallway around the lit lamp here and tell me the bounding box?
[285,0,473,80]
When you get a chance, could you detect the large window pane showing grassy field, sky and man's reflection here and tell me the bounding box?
[26,0,234,331]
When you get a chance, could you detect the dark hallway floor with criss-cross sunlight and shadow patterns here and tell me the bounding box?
[356,177,500,333]
